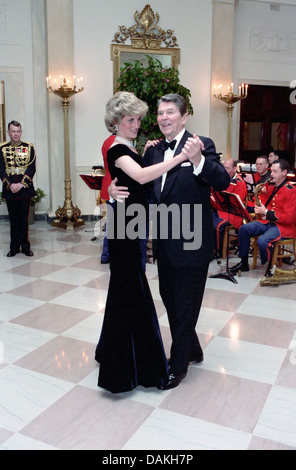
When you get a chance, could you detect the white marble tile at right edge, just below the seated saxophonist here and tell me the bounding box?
[237,295,296,322]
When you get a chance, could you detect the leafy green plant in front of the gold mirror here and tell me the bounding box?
[118,55,193,151]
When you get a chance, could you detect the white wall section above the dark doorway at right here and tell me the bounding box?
[233,0,296,158]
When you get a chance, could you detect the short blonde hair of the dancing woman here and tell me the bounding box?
[105,91,148,133]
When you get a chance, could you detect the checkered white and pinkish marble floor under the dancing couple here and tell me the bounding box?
[0,220,296,450]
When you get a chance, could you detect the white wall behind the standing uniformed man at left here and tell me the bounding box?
[0,0,50,215]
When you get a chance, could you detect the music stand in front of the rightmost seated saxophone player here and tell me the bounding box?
[209,191,252,284]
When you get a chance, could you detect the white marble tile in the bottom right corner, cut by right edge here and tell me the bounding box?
[254,386,296,447]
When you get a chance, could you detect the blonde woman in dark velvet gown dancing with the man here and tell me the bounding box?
[95,92,186,393]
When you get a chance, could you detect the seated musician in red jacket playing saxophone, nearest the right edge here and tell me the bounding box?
[230,159,296,276]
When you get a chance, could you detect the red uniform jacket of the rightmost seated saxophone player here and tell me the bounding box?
[260,182,296,238]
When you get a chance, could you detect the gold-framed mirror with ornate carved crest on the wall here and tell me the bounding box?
[111,5,180,92]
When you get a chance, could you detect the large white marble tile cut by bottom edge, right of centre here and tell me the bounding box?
[123,409,251,451]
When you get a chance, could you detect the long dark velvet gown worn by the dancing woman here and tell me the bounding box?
[95,144,168,393]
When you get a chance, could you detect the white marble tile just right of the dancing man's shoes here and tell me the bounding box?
[200,337,286,384]
